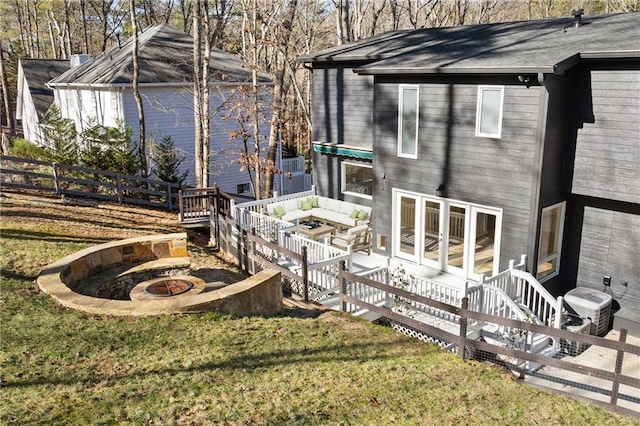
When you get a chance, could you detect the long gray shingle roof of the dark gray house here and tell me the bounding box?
[298,13,640,74]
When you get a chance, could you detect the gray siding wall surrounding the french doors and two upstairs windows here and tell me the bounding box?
[374,80,544,267]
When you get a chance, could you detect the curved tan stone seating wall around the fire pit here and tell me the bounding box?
[37,233,282,316]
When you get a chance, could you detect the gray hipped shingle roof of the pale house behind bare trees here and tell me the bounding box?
[49,24,271,86]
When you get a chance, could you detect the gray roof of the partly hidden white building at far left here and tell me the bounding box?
[20,58,69,120]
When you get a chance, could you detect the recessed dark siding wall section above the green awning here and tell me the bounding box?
[312,68,373,148]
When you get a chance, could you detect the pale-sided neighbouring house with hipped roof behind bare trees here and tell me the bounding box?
[48,24,272,193]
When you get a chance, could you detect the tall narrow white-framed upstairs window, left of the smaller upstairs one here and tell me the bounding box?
[398,85,419,158]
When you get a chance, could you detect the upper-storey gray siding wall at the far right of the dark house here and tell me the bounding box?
[573,64,640,204]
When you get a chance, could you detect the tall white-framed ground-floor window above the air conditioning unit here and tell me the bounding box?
[536,201,567,282]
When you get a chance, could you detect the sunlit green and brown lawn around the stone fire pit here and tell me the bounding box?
[0,195,636,425]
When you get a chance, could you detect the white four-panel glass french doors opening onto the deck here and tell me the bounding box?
[394,190,502,279]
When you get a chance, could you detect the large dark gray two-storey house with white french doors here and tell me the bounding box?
[299,13,640,334]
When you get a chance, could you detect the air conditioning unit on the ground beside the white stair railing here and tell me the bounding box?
[564,287,613,336]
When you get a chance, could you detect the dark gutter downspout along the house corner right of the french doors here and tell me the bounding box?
[527,73,549,277]
